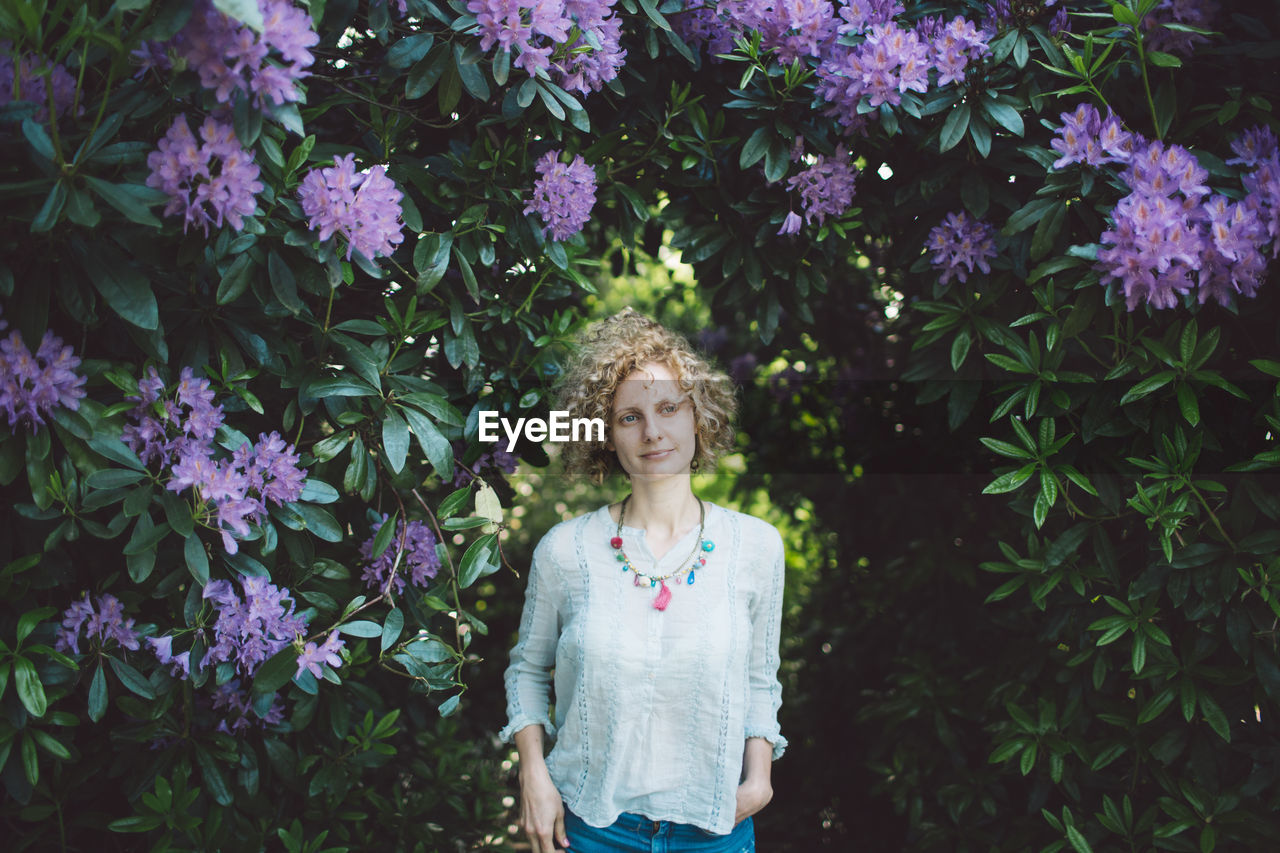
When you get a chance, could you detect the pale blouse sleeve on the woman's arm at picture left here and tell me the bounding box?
[499,538,561,743]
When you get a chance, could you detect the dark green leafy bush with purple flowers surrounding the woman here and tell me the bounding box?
[0,0,1280,850]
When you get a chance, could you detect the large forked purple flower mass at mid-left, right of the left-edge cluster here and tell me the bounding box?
[122,368,306,553]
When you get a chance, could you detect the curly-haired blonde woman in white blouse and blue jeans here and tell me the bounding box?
[502,309,786,853]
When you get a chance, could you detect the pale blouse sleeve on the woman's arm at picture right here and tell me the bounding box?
[746,528,787,761]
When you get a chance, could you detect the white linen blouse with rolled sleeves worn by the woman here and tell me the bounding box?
[500,502,787,835]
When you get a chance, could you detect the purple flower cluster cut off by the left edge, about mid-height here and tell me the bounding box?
[0,316,84,429]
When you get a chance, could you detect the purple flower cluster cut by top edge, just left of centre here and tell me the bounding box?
[467,0,627,95]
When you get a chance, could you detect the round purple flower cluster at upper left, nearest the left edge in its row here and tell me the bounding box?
[147,113,262,234]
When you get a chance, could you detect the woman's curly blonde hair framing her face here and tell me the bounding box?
[556,307,737,484]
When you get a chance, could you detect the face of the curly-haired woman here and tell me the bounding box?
[607,362,698,479]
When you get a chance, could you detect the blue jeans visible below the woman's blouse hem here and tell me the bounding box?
[564,808,755,853]
